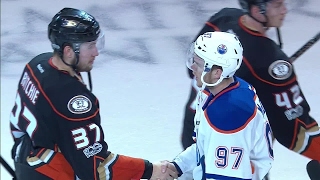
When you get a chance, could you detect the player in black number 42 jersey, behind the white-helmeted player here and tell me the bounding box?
[182,0,320,179]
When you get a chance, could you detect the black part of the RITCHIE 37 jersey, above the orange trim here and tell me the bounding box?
[10,53,110,179]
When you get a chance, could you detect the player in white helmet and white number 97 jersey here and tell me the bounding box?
[172,32,273,180]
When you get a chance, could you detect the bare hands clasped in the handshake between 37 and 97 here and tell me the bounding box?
[150,161,178,180]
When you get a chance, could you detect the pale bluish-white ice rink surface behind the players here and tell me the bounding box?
[1,0,320,180]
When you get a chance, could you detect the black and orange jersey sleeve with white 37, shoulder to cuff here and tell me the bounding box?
[48,83,152,180]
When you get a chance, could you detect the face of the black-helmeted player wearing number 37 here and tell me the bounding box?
[77,41,99,72]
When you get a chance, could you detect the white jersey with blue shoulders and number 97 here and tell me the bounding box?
[174,77,273,180]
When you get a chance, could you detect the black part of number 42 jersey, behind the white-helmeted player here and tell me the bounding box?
[192,8,317,149]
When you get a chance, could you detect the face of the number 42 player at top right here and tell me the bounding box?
[266,0,287,27]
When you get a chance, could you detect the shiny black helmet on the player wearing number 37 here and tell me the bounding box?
[48,8,100,52]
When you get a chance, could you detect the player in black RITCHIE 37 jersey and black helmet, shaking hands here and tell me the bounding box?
[10,8,176,180]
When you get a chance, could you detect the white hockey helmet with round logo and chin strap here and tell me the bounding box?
[194,32,243,86]
